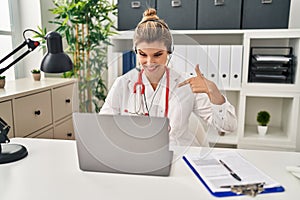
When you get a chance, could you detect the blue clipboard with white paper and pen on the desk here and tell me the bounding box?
[183,152,284,197]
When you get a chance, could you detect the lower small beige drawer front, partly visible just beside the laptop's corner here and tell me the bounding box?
[54,118,75,140]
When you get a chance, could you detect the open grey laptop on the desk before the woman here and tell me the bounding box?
[73,113,173,176]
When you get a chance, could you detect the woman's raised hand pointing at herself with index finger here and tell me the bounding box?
[178,64,225,105]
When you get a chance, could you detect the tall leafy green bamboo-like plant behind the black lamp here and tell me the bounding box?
[47,0,117,112]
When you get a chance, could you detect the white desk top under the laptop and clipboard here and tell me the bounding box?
[0,138,300,200]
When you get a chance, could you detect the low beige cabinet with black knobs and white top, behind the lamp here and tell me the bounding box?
[0,78,78,139]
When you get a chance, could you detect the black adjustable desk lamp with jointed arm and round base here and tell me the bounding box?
[0,29,73,164]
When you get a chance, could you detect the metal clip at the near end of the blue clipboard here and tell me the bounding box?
[221,182,265,197]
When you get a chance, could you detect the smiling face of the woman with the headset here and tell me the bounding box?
[136,41,168,83]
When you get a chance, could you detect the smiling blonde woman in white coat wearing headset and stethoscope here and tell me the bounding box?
[100,8,237,145]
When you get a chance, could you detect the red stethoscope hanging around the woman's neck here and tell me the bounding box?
[133,67,170,117]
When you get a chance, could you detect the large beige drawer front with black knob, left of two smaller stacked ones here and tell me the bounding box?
[14,90,52,137]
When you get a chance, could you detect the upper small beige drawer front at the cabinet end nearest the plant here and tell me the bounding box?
[52,84,74,121]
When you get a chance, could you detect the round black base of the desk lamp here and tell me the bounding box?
[0,144,28,164]
